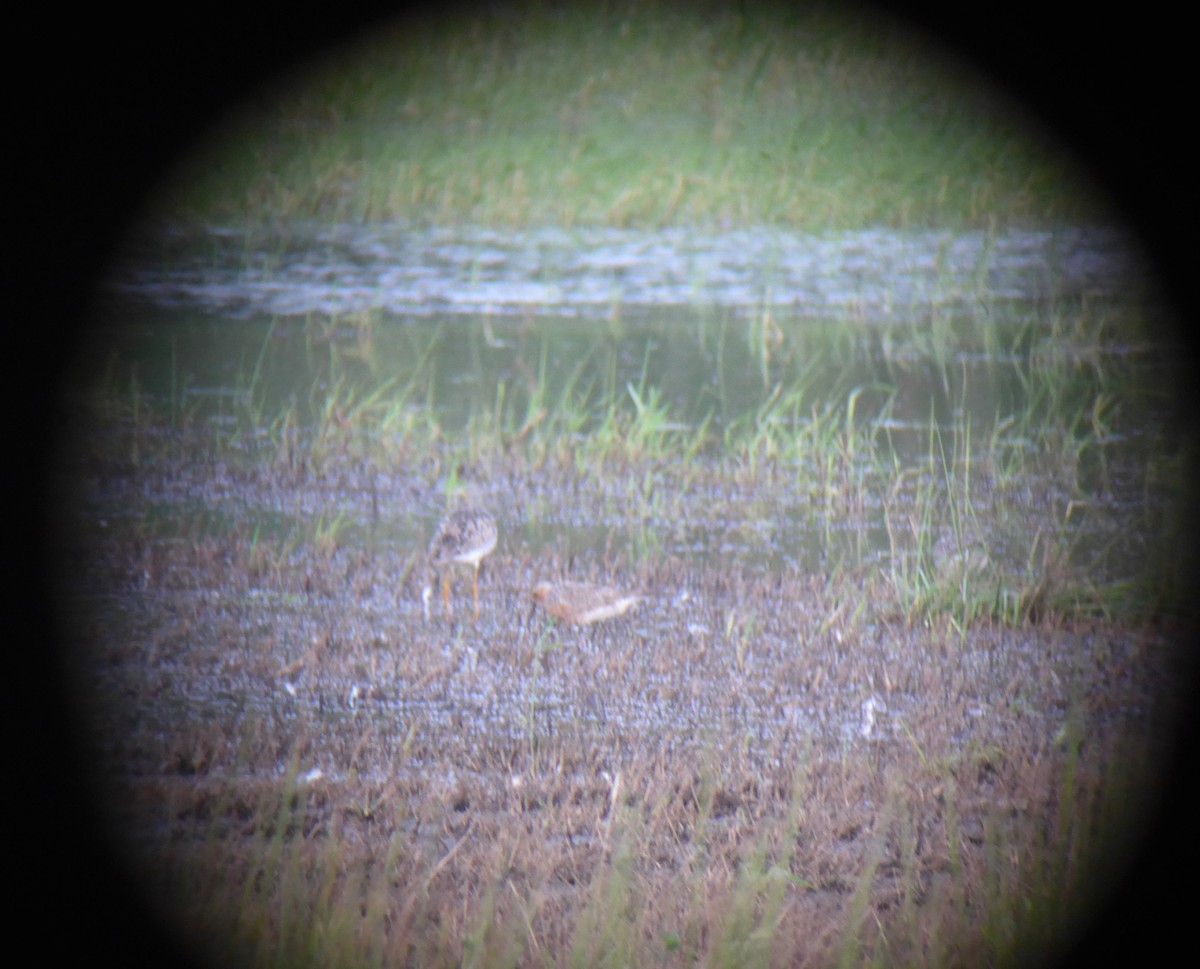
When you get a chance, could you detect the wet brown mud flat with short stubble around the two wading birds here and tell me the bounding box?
[64,417,1171,965]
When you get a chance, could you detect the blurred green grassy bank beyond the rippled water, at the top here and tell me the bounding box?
[164,2,1096,230]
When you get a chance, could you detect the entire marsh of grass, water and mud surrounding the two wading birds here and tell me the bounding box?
[51,1,1189,965]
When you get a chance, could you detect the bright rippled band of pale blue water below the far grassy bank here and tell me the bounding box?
[114,225,1140,321]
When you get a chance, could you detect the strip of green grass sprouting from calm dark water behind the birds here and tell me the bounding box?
[82,291,1187,630]
